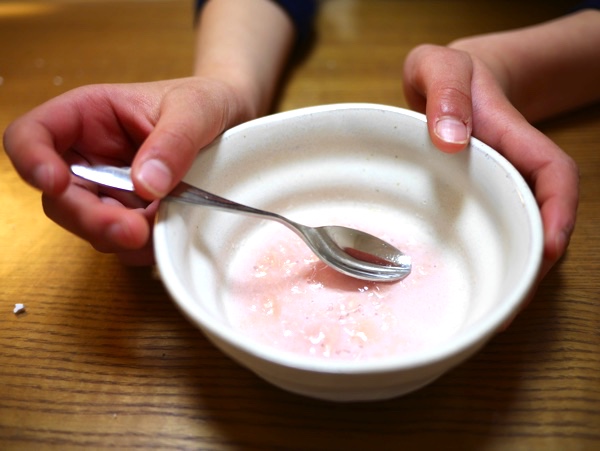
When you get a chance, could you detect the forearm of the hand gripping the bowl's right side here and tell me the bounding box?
[450,10,600,122]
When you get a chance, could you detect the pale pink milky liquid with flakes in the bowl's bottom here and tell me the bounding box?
[227,210,469,360]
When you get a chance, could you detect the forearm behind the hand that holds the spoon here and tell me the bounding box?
[194,0,295,120]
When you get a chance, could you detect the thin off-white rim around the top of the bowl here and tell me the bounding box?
[153,102,544,375]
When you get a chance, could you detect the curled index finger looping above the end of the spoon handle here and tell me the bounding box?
[4,85,149,196]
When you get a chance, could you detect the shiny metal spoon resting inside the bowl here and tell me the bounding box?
[71,165,411,282]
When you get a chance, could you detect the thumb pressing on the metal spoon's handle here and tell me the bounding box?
[132,81,230,200]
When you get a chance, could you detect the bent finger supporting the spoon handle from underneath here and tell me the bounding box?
[42,185,152,252]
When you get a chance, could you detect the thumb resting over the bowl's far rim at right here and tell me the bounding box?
[403,45,473,152]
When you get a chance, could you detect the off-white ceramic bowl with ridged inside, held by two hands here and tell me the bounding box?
[154,104,543,401]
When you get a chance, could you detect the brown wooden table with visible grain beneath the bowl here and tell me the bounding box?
[0,0,600,450]
